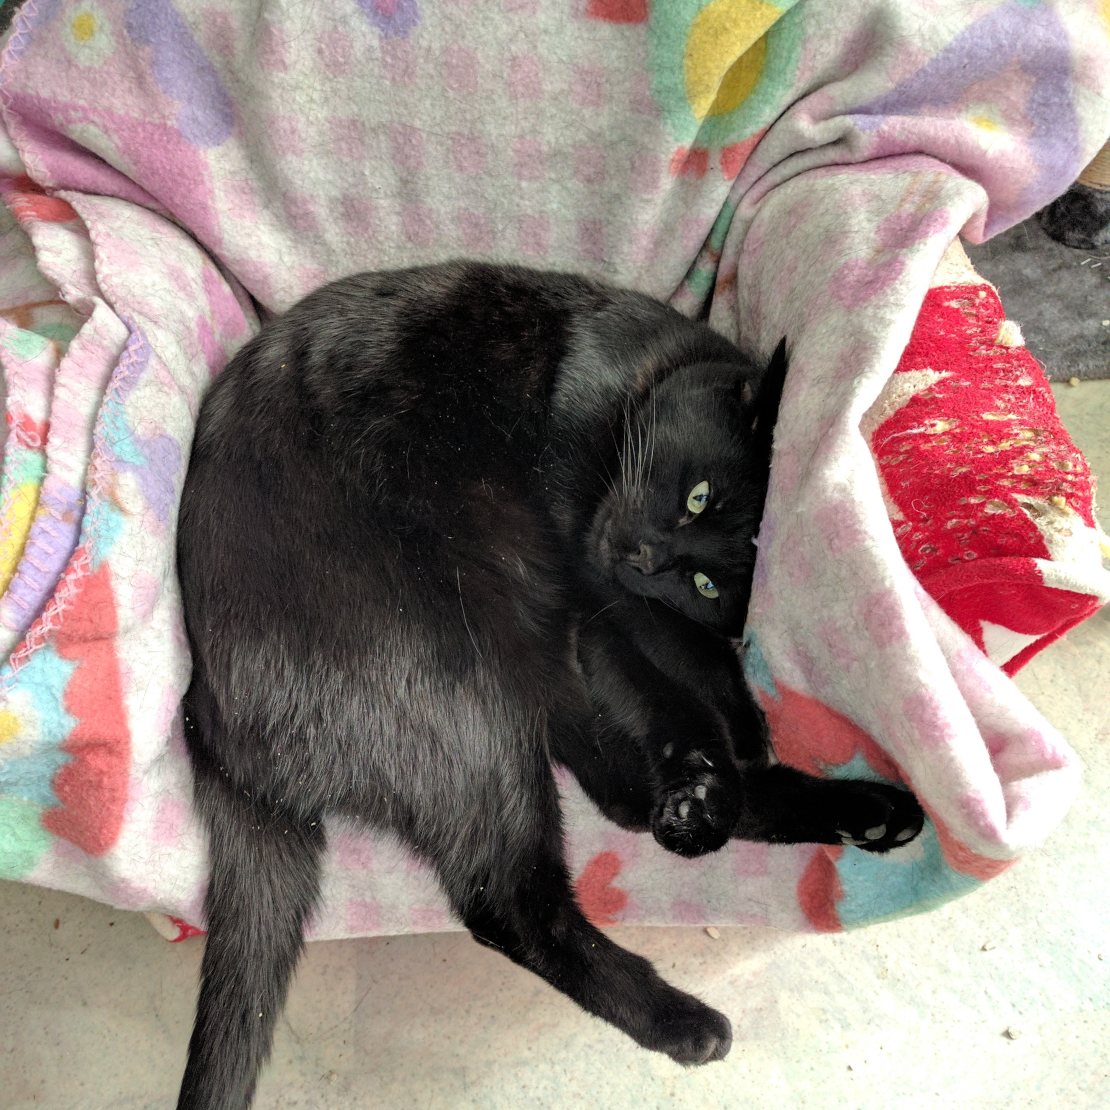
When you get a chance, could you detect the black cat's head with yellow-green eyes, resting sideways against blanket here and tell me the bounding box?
[586,342,786,636]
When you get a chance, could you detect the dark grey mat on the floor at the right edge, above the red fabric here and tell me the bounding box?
[963,218,1110,382]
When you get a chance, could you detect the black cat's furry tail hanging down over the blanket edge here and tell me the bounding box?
[178,746,325,1110]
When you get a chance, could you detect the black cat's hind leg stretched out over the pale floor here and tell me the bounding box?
[377,679,731,1063]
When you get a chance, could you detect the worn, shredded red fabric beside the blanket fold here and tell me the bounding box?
[871,284,1100,674]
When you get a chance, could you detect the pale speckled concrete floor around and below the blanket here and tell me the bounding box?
[0,397,1110,1110]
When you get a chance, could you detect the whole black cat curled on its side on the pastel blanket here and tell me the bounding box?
[170,263,921,1110]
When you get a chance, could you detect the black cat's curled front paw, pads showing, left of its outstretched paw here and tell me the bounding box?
[652,751,740,856]
